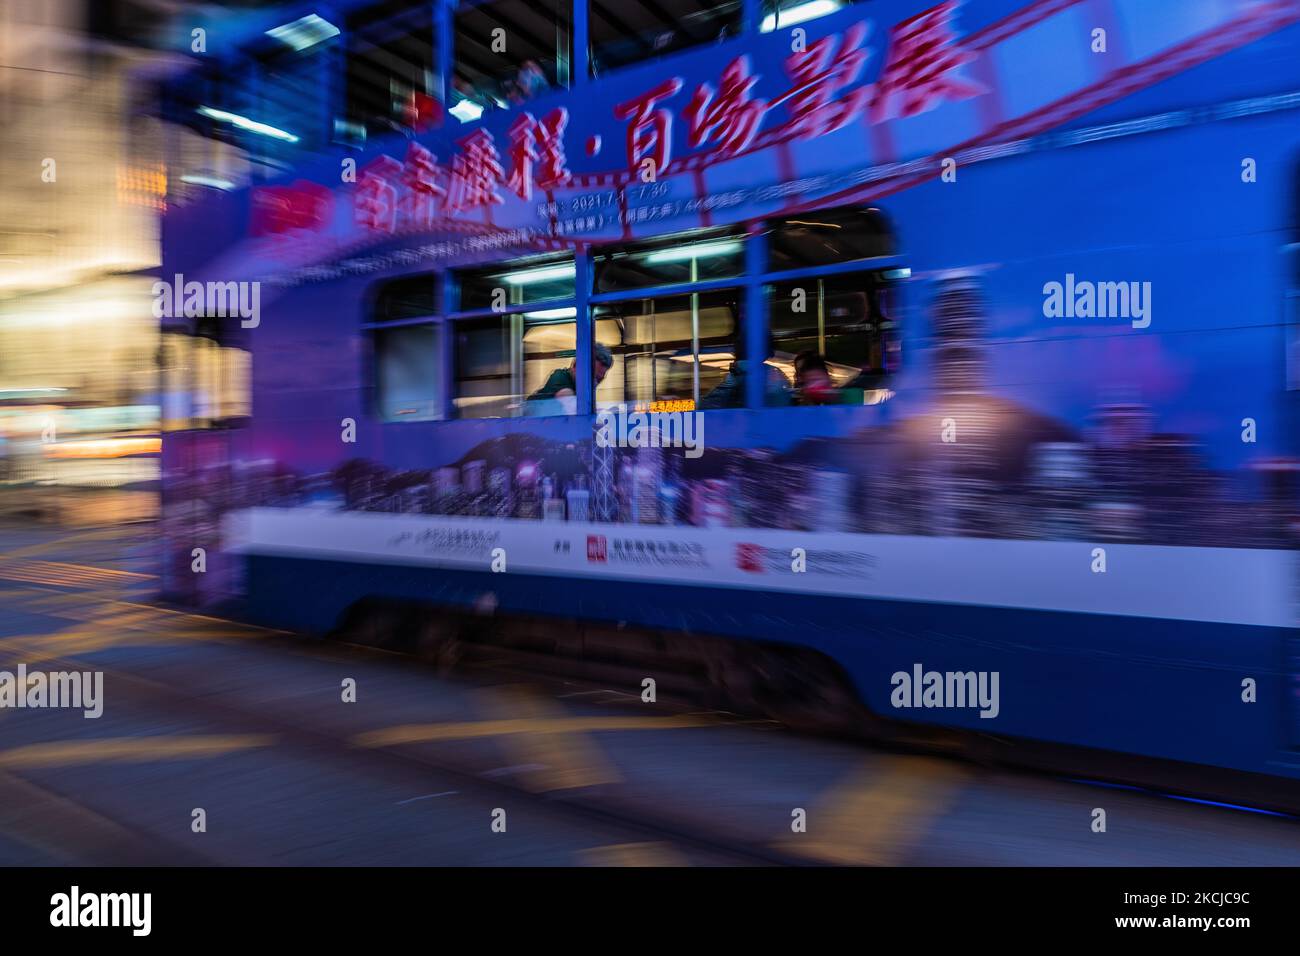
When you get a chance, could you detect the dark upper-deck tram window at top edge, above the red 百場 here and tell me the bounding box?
[588,0,743,77]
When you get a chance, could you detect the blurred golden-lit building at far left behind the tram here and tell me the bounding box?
[0,0,178,484]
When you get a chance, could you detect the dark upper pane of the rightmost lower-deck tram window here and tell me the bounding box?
[768,208,897,272]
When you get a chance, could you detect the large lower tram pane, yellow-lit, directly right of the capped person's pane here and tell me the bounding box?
[594,289,744,408]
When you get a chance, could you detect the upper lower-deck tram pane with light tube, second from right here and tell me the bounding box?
[594,233,745,293]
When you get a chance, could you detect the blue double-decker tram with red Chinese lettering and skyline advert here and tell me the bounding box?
[155,0,1300,803]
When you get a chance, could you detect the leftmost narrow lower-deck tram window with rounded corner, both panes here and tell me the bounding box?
[361,273,447,424]
